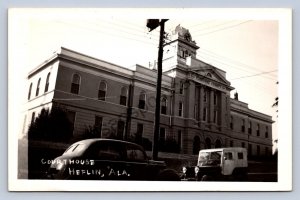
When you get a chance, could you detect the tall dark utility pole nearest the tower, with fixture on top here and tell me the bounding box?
[147,19,168,160]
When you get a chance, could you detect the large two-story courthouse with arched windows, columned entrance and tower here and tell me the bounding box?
[23,26,273,156]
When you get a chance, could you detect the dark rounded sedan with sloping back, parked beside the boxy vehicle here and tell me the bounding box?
[47,139,180,181]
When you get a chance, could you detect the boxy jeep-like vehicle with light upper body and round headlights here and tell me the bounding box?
[181,147,248,181]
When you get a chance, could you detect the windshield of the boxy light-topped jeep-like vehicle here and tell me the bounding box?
[198,151,222,166]
